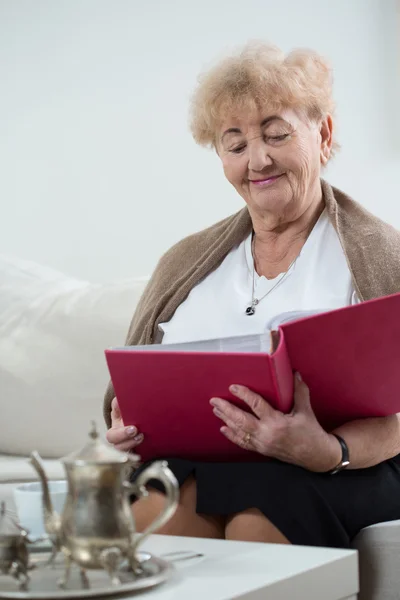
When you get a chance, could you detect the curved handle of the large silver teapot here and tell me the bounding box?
[126,460,179,552]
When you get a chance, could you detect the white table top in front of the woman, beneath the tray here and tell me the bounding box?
[141,535,358,600]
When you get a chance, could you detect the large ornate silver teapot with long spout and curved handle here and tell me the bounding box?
[30,424,179,588]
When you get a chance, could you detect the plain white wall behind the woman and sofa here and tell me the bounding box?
[0,0,400,281]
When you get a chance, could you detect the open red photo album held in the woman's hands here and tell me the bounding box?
[106,294,400,461]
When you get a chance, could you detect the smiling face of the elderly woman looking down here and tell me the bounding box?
[217,109,332,224]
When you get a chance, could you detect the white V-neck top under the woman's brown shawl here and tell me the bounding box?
[160,210,358,344]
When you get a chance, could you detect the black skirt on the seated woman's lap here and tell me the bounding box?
[132,455,400,548]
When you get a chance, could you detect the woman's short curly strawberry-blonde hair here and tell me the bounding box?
[190,42,338,155]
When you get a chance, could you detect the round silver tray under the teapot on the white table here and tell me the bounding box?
[0,552,174,600]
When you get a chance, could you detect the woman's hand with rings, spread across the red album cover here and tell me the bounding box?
[210,374,342,472]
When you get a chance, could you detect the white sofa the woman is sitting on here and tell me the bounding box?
[0,255,400,600]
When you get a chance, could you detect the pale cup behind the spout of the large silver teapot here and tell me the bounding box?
[14,480,68,538]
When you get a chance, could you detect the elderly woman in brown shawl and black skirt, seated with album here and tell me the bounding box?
[105,45,400,547]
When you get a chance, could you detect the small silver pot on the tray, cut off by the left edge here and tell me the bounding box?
[0,502,33,591]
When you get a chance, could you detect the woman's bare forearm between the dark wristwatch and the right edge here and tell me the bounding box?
[332,413,400,469]
